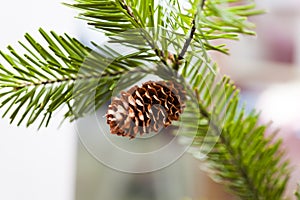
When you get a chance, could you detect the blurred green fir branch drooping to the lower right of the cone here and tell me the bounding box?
[182,59,289,199]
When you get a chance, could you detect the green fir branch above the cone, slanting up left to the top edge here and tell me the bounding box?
[66,0,168,64]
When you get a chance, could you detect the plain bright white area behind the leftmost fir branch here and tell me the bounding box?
[0,0,78,200]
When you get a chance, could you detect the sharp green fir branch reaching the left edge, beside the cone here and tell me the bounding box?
[0,29,144,126]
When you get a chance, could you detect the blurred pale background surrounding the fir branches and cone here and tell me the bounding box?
[0,0,300,200]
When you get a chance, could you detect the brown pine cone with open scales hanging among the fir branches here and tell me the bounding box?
[106,81,186,138]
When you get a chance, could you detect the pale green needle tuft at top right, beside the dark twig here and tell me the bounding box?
[173,0,263,54]
